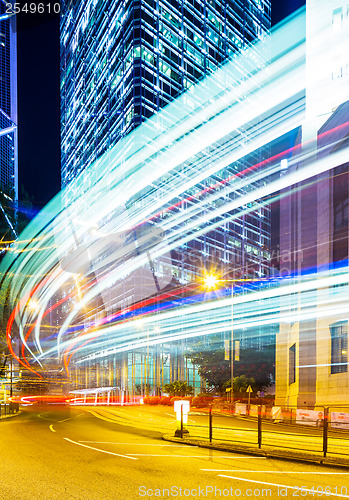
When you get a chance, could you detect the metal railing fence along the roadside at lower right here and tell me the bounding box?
[181,405,349,458]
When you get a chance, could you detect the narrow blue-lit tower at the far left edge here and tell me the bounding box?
[0,1,18,198]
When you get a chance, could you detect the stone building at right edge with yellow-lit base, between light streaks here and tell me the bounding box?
[276,0,349,411]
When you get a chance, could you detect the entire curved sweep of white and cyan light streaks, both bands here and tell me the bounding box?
[1,6,349,378]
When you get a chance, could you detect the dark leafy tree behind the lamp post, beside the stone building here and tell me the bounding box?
[187,342,275,395]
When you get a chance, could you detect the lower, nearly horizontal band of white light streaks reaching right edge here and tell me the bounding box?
[36,267,348,361]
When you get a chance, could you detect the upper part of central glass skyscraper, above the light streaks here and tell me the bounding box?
[61,0,270,186]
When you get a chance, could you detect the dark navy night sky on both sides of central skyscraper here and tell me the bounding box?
[17,0,305,208]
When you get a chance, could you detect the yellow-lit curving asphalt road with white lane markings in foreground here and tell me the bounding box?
[0,407,349,500]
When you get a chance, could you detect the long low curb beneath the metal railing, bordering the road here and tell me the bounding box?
[163,435,349,468]
